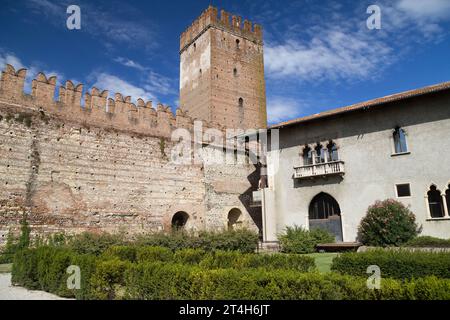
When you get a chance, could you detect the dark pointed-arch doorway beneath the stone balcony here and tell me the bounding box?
[309,192,343,242]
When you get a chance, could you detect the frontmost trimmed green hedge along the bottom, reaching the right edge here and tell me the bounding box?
[125,263,450,300]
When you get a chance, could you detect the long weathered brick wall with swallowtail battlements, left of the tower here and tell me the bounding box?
[0,65,260,241]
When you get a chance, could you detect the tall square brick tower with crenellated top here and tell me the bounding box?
[180,6,267,129]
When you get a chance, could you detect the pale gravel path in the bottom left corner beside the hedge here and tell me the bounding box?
[0,273,65,300]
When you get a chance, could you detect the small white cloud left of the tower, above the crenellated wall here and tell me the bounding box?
[90,72,156,101]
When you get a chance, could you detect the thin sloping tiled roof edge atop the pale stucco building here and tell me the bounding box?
[270,81,450,129]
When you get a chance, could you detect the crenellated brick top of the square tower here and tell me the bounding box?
[180,6,263,53]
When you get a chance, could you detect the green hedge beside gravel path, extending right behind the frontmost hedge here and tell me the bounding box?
[12,246,315,299]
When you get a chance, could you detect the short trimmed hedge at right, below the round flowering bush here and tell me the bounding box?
[331,249,450,279]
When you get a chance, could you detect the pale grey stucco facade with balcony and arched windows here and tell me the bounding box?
[263,89,450,242]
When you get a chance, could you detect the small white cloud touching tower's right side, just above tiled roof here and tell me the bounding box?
[267,97,305,124]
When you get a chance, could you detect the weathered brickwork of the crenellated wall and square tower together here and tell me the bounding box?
[0,7,266,241]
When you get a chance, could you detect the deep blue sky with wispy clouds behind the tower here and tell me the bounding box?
[0,0,450,123]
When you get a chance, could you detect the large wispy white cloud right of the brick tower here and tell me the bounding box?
[264,29,392,81]
